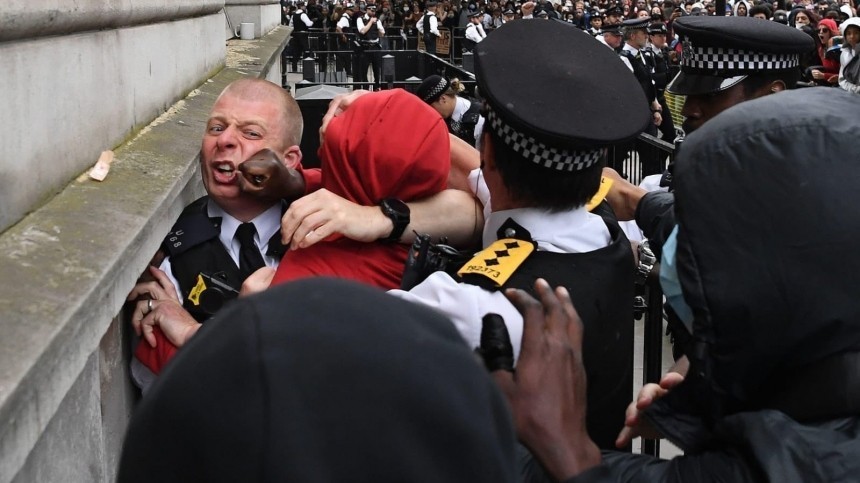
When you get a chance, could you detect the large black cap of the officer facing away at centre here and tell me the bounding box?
[475,21,651,171]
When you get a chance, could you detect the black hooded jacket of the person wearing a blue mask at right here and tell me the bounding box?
[571,88,860,483]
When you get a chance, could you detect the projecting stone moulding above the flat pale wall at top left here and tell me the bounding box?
[0,0,225,41]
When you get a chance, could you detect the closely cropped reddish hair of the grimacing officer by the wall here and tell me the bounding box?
[215,77,304,149]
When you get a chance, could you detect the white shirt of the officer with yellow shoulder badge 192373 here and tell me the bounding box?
[389,183,611,360]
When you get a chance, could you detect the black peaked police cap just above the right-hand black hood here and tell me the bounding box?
[667,17,814,95]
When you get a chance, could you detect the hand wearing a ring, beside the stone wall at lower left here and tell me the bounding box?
[131,300,201,347]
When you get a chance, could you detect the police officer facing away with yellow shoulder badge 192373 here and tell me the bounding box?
[395,20,651,449]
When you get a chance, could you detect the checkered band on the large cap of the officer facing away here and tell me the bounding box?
[487,106,604,171]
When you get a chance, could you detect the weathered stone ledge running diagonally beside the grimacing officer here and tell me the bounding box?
[0,27,289,482]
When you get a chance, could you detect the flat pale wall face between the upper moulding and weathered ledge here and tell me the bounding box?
[0,12,225,231]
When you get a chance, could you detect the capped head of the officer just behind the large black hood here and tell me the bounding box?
[667,17,815,134]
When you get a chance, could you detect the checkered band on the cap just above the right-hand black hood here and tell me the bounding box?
[681,40,800,72]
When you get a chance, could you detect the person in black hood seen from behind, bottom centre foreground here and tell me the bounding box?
[117,278,515,483]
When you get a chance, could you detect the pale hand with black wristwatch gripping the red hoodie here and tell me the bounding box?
[281,188,394,250]
